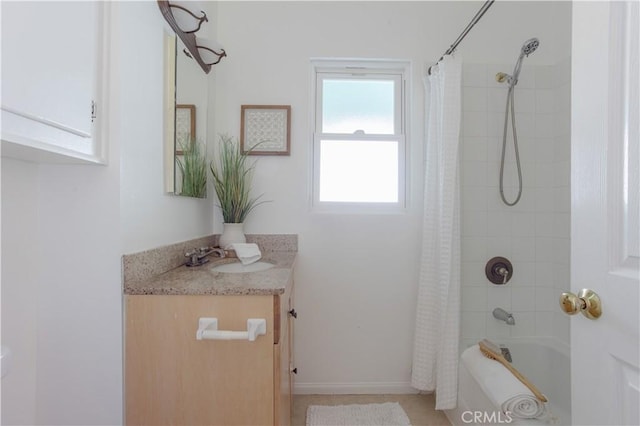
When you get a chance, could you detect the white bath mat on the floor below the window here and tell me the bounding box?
[307,402,411,426]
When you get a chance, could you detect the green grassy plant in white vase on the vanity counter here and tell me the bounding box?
[210,135,263,249]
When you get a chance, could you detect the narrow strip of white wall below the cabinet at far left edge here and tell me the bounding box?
[1,158,40,425]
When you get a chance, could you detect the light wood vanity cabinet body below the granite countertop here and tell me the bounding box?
[125,280,293,426]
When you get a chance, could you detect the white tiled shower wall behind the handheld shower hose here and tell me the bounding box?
[461,58,571,349]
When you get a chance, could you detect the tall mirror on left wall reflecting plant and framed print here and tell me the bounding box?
[165,35,209,198]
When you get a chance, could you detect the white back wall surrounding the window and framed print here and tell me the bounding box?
[214,2,557,392]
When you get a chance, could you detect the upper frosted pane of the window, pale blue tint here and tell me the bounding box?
[322,79,395,135]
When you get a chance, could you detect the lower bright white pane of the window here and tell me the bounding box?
[319,140,398,203]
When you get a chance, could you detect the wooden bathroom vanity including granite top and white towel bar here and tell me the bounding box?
[124,236,296,425]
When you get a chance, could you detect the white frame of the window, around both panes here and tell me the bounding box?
[310,59,411,213]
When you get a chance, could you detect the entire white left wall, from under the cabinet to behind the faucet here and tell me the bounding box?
[2,1,213,425]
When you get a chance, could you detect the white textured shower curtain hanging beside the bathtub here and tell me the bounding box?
[411,55,462,410]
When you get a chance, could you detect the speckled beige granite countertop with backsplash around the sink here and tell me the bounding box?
[123,235,297,296]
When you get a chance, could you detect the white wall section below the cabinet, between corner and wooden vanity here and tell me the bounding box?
[35,162,122,424]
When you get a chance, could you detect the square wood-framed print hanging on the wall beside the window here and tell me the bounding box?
[240,105,291,155]
